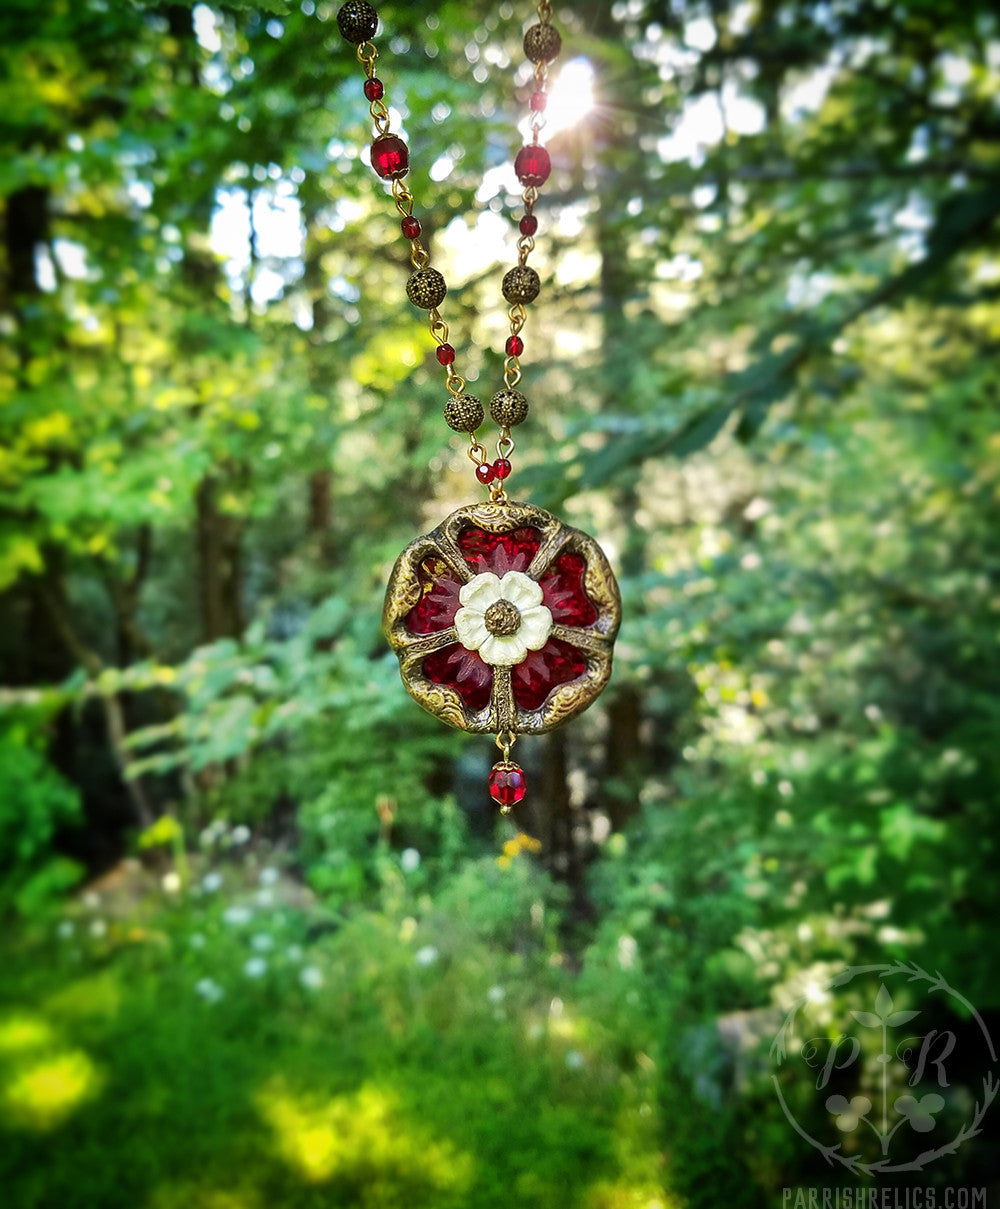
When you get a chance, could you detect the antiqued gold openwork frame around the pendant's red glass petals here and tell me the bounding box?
[382,502,622,735]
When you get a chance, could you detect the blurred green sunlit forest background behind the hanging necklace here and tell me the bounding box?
[0,0,1000,1209]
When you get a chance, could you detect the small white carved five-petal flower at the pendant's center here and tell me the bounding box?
[455,571,553,667]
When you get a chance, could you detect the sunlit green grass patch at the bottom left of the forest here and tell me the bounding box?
[0,865,674,1209]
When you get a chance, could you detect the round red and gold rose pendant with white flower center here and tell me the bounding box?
[382,503,622,735]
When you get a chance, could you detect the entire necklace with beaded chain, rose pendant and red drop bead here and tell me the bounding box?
[337,0,622,814]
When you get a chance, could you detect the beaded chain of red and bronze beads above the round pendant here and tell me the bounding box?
[337,0,562,503]
